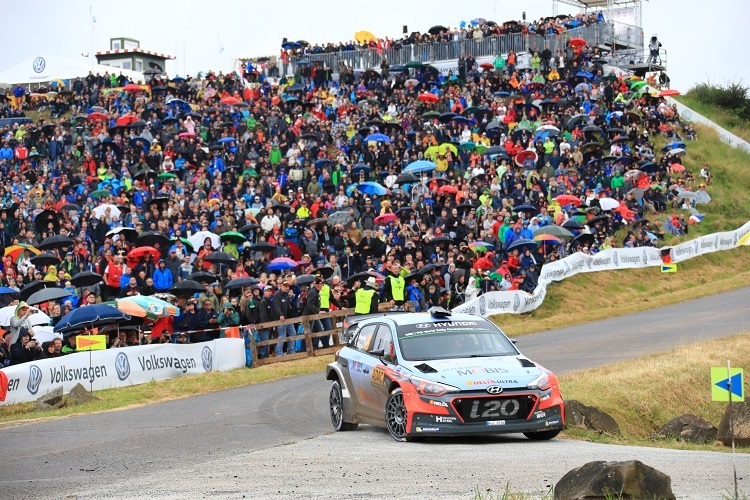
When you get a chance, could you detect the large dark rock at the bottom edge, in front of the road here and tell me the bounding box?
[555,460,675,500]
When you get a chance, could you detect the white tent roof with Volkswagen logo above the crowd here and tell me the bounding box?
[0,56,144,85]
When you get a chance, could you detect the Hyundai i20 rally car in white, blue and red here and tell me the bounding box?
[326,308,565,441]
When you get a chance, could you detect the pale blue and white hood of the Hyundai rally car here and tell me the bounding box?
[404,356,542,391]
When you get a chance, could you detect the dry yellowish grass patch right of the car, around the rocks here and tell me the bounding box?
[560,332,750,453]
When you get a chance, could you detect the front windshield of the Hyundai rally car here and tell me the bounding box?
[396,318,518,361]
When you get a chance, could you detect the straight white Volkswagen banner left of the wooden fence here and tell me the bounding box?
[0,339,245,404]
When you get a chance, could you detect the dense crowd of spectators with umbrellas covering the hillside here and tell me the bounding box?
[0,18,708,362]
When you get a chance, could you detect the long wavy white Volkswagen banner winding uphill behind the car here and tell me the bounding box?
[453,222,750,316]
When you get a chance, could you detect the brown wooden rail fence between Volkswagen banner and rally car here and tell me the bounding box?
[244,304,389,366]
